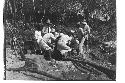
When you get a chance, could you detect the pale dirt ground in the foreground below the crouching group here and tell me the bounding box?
[5,48,108,81]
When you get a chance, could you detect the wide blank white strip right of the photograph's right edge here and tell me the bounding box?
[116,0,125,83]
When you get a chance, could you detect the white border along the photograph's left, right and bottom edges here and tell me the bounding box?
[0,0,125,83]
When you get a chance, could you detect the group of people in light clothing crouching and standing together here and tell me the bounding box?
[35,21,90,61]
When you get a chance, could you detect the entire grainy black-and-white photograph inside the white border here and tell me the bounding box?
[3,0,117,81]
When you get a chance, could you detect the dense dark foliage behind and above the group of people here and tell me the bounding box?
[4,0,117,65]
